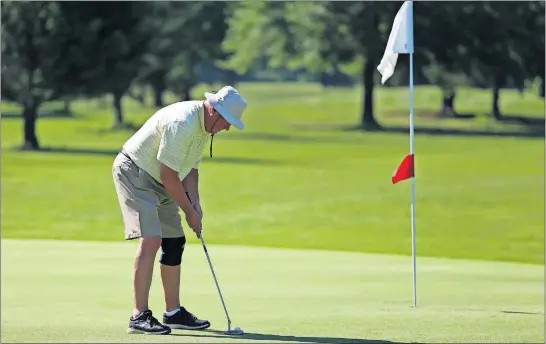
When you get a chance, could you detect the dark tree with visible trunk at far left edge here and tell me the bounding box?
[1,1,82,150]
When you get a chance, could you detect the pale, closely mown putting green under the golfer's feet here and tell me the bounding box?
[2,241,544,343]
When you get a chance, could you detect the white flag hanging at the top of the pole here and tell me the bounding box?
[377,1,413,84]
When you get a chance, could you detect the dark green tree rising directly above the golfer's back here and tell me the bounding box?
[139,1,231,107]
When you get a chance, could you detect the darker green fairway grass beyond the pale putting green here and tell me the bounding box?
[2,84,544,264]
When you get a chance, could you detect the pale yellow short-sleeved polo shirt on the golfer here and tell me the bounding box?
[123,101,210,183]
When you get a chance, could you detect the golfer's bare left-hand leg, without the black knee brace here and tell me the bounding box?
[133,237,161,317]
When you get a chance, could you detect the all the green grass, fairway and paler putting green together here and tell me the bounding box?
[1,84,544,344]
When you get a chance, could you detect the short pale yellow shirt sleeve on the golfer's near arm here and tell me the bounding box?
[157,122,192,172]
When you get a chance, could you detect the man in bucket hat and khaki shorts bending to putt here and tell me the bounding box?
[112,86,247,334]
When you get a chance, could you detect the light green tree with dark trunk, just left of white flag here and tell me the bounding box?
[220,1,400,130]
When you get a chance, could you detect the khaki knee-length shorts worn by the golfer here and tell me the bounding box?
[112,153,184,240]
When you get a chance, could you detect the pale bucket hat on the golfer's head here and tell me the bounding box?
[205,86,247,130]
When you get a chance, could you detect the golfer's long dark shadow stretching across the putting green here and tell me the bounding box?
[171,330,409,344]
